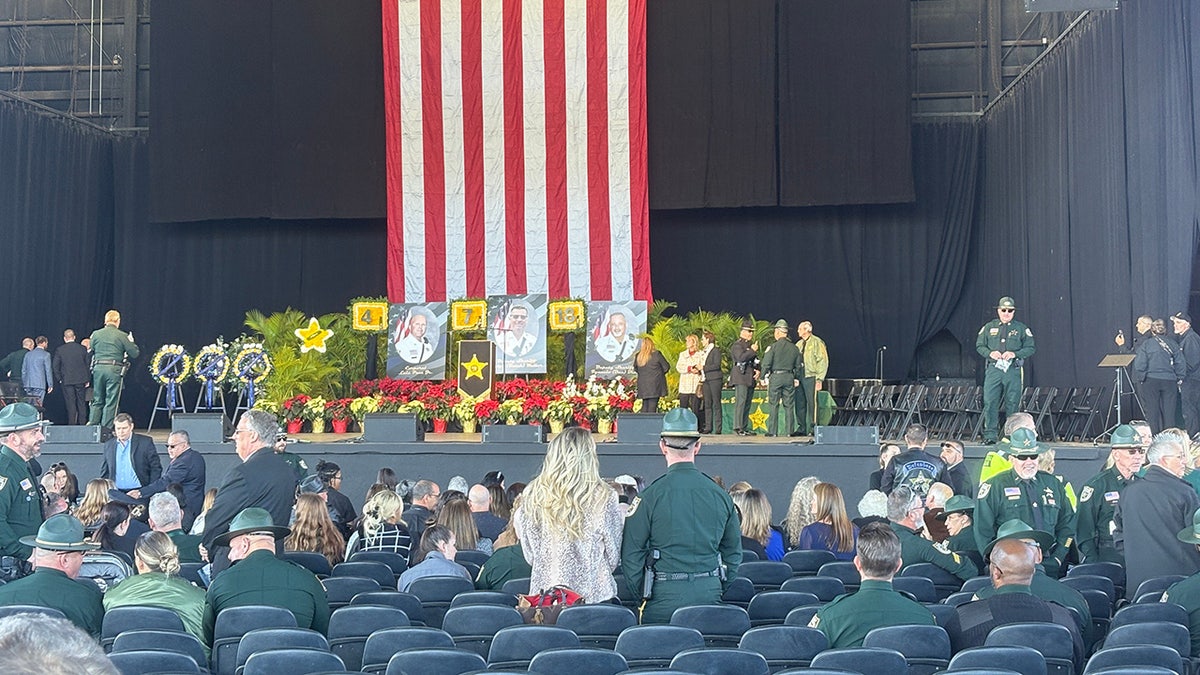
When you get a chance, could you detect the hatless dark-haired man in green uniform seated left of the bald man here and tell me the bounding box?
[809,522,936,649]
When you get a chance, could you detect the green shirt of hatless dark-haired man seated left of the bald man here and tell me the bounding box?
[809,579,937,649]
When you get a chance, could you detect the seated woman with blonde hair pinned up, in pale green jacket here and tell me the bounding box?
[104,532,208,652]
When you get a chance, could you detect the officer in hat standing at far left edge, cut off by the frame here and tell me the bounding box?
[0,404,49,560]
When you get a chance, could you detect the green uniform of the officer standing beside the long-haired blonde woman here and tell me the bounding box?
[620,461,739,619]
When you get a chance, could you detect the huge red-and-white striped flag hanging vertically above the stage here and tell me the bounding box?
[383,0,650,303]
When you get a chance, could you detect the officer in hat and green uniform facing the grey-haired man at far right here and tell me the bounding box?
[1075,424,1146,565]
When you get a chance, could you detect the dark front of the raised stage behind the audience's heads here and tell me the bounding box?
[38,428,1109,511]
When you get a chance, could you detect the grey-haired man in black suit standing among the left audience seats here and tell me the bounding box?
[204,410,296,575]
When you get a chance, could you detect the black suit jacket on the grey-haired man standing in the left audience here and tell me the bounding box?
[204,447,296,574]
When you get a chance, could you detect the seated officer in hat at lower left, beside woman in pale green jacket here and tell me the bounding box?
[0,513,104,637]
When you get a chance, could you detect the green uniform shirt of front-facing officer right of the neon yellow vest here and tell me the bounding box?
[974,468,1075,577]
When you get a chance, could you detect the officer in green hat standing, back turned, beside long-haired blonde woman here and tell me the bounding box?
[620,403,739,623]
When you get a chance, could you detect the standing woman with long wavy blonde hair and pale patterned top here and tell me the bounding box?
[512,426,624,603]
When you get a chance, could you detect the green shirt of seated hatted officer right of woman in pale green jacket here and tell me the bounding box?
[204,550,329,646]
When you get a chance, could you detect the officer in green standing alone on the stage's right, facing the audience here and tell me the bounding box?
[976,295,1037,446]
